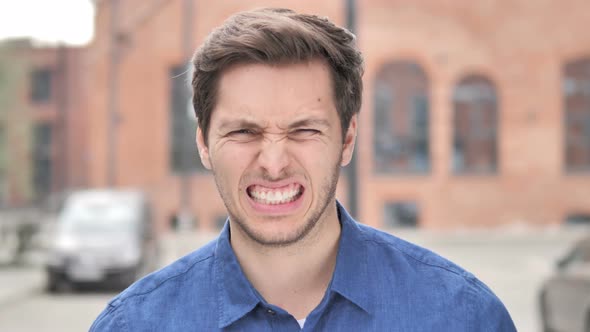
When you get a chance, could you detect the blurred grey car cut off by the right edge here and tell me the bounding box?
[540,237,590,332]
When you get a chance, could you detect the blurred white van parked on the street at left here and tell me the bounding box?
[46,190,158,292]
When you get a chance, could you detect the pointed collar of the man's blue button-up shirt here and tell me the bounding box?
[214,202,372,329]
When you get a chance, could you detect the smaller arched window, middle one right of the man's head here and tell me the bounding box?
[452,75,498,174]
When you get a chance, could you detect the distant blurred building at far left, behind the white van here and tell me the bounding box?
[0,39,88,207]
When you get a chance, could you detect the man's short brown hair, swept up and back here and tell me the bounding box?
[192,8,363,144]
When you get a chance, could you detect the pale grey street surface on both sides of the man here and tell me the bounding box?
[0,229,587,332]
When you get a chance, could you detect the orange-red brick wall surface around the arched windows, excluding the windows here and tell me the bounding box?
[77,0,590,229]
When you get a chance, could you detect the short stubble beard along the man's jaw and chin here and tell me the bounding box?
[213,157,342,247]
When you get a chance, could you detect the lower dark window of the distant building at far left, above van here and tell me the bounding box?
[33,123,52,199]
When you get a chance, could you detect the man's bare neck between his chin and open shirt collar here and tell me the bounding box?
[231,205,340,319]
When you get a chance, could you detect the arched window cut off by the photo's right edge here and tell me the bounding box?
[562,58,590,172]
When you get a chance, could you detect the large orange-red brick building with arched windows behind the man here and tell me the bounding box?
[5,0,590,229]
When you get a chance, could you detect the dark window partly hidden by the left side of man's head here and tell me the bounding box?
[170,66,204,173]
